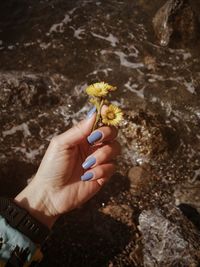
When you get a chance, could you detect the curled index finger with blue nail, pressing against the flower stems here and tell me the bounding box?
[87,126,118,145]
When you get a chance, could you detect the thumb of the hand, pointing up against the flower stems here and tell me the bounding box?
[57,107,96,146]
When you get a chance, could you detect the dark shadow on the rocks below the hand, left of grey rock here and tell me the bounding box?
[40,175,133,267]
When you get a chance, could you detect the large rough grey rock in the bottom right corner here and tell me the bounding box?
[139,209,200,267]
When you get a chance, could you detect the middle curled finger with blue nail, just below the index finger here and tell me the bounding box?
[82,141,121,170]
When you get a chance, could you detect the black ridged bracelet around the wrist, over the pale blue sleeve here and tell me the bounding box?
[0,197,50,244]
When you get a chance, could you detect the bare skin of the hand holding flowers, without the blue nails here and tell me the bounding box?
[15,108,120,228]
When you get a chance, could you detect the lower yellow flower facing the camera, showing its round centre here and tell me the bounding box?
[102,104,123,126]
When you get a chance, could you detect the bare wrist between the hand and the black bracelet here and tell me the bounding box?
[14,180,58,229]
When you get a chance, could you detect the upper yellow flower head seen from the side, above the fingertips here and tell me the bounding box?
[86,82,116,97]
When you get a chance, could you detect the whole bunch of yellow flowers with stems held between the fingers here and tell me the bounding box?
[86,82,123,130]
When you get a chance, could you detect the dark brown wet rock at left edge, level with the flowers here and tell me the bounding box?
[0,72,68,111]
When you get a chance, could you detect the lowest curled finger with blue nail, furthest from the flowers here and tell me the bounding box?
[81,163,116,184]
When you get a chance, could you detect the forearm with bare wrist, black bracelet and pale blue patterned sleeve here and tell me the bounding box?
[0,184,49,267]
